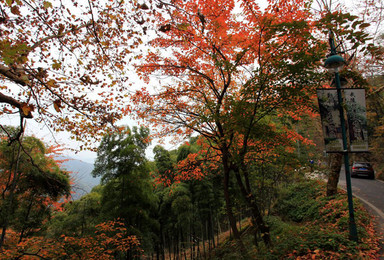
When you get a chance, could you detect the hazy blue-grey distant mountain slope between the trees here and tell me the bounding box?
[58,156,101,200]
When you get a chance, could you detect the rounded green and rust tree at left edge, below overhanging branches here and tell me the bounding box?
[0,128,70,248]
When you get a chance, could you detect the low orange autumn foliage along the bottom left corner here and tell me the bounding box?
[0,220,142,260]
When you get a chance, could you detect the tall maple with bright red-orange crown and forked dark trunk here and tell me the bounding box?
[133,0,325,250]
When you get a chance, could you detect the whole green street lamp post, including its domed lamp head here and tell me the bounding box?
[324,34,358,242]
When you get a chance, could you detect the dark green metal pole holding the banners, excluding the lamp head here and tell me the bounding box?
[329,35,358,242]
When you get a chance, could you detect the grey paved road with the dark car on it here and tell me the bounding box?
[339,167,384,259]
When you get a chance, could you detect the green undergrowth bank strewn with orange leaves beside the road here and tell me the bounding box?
[211,181,379,260]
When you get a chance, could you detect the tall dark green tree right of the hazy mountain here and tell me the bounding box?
[92,127,157,255]
